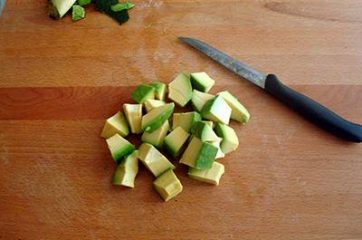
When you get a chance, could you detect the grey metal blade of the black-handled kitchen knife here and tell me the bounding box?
[178,37,266,88]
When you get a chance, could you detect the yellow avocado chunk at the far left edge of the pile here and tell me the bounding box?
[101,112,129,138]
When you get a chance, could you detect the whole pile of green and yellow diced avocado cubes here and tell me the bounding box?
[101,72,250,201]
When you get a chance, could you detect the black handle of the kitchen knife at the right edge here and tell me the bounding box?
[265,74,362,143]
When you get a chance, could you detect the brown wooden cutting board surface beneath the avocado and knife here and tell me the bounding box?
[0,0,362,240]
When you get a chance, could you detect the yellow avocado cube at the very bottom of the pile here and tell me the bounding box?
[153,169,182,202]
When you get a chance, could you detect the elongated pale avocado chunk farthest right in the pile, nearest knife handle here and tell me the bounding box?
[218,91,250,123]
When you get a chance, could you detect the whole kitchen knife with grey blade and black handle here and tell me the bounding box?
[179,37,362,143]
